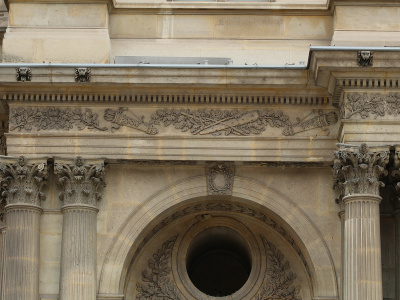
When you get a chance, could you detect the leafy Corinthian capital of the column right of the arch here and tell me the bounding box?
[333,144,389,196]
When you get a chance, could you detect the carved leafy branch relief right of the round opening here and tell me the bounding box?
[256,237,302,300]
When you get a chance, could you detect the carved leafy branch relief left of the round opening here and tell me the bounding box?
[136,235,181,300]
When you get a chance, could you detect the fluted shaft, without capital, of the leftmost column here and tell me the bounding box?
[5,204,42,300]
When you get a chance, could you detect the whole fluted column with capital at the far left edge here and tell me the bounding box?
[0,157,48,300]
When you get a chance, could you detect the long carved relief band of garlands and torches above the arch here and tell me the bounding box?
[10,107,338,136]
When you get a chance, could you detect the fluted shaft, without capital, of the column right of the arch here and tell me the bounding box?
[343,194,383,300]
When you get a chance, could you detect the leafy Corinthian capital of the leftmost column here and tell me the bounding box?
[0,156,48,206]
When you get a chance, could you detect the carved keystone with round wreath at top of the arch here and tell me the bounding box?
[206,162,235,195]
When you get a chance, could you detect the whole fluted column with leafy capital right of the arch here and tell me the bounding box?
[334,144,389,300]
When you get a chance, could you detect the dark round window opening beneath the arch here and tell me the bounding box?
[186,226,251,297]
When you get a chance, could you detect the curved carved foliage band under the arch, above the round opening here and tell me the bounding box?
[128,202,312,280]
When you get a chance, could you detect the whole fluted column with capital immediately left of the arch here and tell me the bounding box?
[55,157,105,300]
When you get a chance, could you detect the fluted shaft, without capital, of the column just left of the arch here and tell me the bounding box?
[60,205,98,300]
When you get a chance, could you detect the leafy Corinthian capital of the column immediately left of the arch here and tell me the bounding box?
[54,156,105,206]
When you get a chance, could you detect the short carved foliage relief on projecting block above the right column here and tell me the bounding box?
[342,93,400,119]
